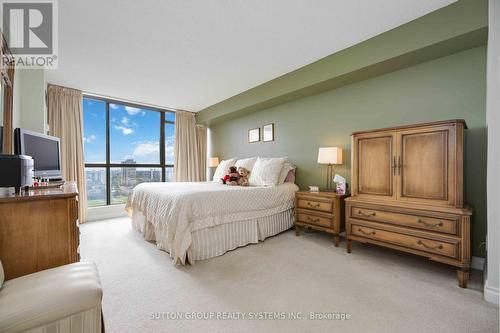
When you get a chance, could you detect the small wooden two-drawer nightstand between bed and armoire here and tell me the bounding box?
[295,191,348,247]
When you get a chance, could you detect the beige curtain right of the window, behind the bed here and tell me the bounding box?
[174,111,207,182]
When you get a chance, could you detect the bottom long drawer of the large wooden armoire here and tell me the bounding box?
[350,222,460,258]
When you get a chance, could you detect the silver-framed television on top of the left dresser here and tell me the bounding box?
[14,128,61,179]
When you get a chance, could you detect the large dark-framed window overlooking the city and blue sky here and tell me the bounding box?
[83,96,175,207]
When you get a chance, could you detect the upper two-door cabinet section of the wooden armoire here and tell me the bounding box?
[352,121,465,207]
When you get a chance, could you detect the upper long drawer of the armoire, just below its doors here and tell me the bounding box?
[349,206,458,235]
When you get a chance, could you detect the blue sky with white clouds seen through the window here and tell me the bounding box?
[83,98,175,164]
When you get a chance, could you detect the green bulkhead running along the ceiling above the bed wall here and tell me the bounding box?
[197,0,488,125]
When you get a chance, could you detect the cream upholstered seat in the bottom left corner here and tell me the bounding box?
[0,262,102,333]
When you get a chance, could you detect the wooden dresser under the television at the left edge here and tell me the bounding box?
[0,189,80,279]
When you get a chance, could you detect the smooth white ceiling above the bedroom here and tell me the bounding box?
[48,0,454,111]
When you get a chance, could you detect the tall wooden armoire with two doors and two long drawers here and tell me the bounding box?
[346,120,472,288]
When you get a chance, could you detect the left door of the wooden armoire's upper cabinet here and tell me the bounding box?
[352,131,397,200]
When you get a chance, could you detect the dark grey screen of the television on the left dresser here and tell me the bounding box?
[23,133,60,171]
